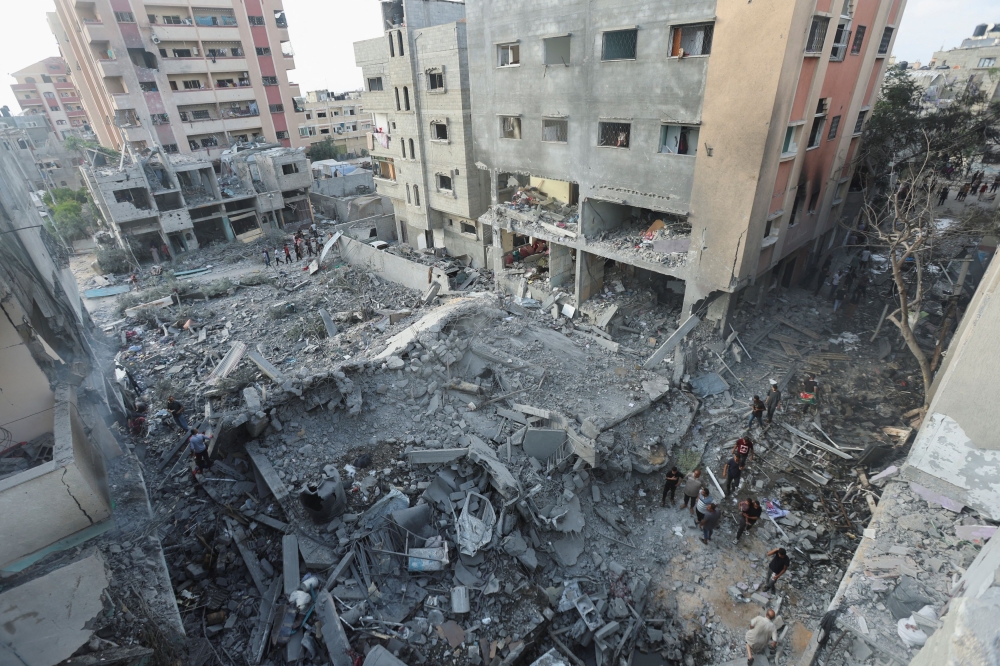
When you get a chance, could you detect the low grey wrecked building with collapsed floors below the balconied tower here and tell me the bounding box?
[83,144,312,256]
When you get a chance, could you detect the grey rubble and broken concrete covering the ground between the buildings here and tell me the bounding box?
[58,235,948,666]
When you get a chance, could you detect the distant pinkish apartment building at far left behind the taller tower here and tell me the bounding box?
[10,57,93,139]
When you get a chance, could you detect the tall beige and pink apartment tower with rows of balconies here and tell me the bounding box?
[49,0,302,160]
